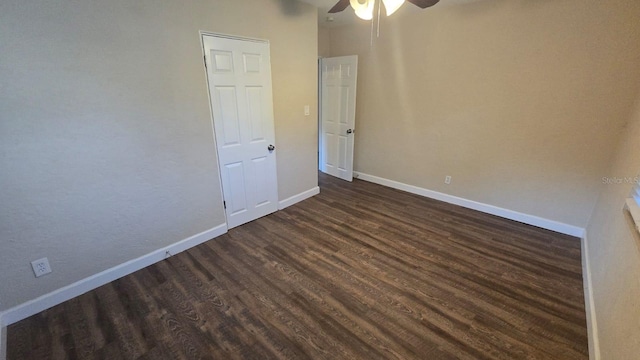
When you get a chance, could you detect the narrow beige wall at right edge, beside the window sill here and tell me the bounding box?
[587,97,640,359]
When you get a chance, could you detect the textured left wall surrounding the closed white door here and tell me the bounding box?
[0,0,317,311]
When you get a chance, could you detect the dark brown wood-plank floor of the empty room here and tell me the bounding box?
[8,175,588,360]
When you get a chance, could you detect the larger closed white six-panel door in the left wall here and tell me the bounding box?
[203,35,278,228]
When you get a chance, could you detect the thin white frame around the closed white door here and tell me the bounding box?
[198,30,280,230]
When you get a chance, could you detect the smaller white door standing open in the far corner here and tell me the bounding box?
[319,55,358,181]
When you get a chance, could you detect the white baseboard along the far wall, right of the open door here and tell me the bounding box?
[354,171,584,238]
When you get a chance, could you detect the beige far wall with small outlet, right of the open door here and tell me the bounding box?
[330,0,640,227]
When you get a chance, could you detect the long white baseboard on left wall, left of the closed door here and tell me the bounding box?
[0,223,227,328]
